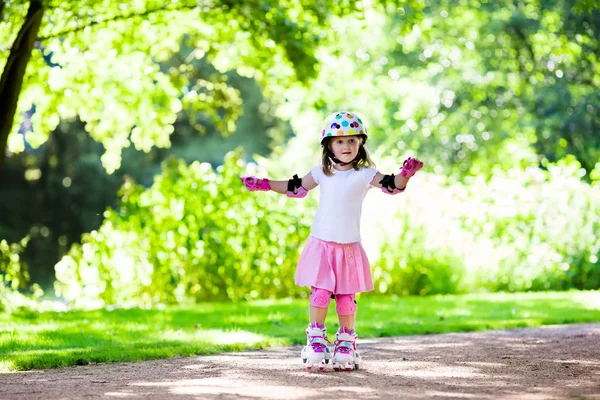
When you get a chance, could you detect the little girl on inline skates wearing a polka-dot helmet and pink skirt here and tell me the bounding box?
[241,111,423,370]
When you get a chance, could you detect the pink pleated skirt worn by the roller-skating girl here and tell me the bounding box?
[296,236,373,294]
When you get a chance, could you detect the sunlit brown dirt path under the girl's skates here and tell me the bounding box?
[0,324,600,400]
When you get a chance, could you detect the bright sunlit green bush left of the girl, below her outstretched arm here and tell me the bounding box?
[55,153,312,304]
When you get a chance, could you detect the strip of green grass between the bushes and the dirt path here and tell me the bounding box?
[0,291,600,372]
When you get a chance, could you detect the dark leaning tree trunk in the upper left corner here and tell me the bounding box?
[0,0,44,171]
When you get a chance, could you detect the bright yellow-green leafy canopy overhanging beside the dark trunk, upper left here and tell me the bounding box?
[0,0,418,172]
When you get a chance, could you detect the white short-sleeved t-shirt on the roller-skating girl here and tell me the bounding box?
[310,165,377,243]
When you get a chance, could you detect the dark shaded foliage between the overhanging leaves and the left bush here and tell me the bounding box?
[0,70,289,289]
